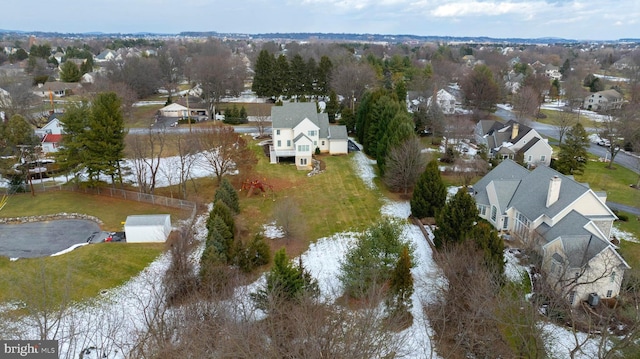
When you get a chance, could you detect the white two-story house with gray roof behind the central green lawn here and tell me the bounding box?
[270,102,348,169]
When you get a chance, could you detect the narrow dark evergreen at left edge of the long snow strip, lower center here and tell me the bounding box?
[386,246,413,315]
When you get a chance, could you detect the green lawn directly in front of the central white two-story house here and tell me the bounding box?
[238,146,382,255]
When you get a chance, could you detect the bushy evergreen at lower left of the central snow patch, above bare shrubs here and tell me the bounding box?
[252,248,320,310]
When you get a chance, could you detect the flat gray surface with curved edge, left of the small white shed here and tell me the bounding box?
[0,219,100,258]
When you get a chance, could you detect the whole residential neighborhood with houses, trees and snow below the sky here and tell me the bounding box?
[0,20,640,359]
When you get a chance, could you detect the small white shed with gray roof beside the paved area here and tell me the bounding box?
[124,214,171,243]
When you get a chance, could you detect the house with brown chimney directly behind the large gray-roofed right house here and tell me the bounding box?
[475,120,553,167]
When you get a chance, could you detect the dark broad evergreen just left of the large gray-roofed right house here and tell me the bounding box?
[434,187,479,248]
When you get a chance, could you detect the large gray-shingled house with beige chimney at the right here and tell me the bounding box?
[473,160,630,305]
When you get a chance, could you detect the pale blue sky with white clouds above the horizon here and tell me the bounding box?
[5,0,640,40]
